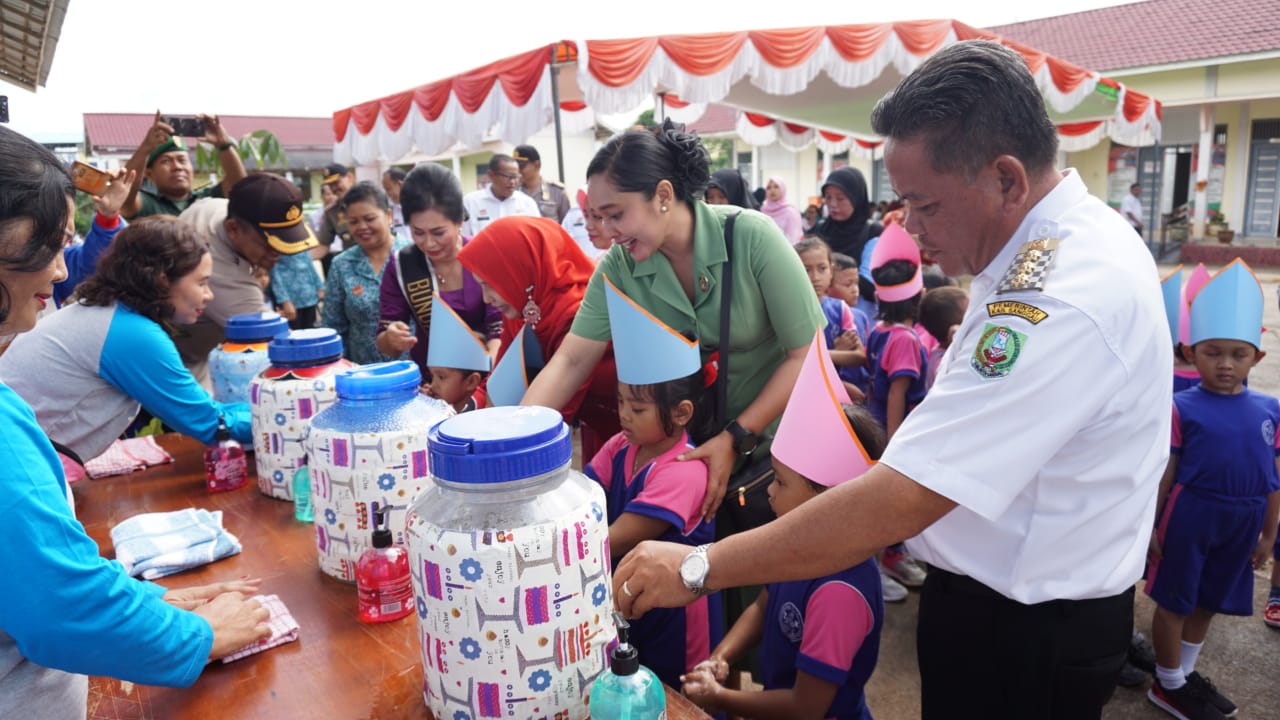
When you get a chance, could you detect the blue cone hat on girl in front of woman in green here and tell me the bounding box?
[604,275,703,386]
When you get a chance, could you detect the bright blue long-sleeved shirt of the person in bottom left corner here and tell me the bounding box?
[0,384,214,717]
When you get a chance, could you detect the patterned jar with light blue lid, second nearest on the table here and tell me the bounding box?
[303,361,449,582]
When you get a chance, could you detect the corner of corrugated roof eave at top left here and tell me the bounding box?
[0,0,68,92]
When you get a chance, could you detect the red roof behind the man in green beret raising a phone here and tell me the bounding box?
[84,113,333,151]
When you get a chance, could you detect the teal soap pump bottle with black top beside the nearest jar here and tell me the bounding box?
[589,612,667,720]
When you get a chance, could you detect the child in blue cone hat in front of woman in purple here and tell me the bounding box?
[426,295,493,413]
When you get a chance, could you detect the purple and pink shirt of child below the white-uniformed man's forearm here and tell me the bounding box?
[760,560,884,720]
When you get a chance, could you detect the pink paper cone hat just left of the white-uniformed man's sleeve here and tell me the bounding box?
[773,331,876,487]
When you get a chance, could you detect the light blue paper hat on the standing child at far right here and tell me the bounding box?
[1190,259,1263,348]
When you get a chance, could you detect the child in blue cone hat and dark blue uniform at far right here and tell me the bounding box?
[1146,260,1280,717]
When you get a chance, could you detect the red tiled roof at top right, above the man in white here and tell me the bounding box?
[987,0,1280,72]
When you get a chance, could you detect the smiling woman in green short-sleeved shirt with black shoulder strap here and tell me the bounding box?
[524,120,823,517]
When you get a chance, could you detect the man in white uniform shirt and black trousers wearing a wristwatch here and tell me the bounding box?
[613,41,1172,720]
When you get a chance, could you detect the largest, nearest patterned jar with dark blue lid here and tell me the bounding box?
[406,407,616,720]
